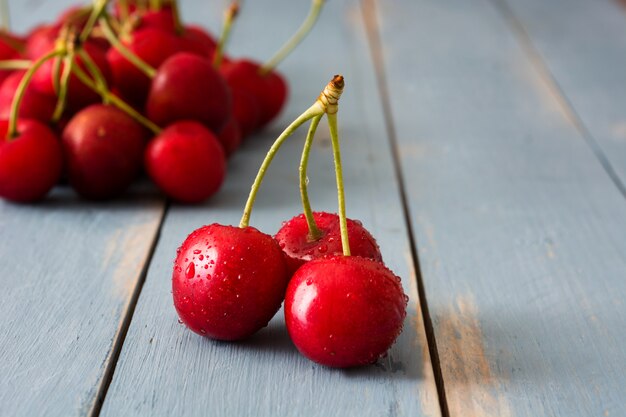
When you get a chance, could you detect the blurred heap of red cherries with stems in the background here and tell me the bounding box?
[0,0,304,203]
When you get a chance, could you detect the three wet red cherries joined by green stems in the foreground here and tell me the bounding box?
[172,76,408,368]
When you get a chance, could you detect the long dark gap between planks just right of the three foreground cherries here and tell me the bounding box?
[361,0,448,417]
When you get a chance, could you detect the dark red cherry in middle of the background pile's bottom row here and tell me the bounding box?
[62,104,147,199]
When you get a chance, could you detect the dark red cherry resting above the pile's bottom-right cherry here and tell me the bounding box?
[146,52,231,132]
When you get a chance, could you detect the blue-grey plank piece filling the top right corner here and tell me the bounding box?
[504,0,626,188]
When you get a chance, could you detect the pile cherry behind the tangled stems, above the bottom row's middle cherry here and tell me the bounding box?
[32,42,112,112]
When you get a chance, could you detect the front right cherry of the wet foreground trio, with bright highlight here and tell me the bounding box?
[285,256,408,368]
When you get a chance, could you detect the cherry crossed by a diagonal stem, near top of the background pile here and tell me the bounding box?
[106,28,179,109]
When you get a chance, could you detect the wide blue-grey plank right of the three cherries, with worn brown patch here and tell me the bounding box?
[376,0,626,417]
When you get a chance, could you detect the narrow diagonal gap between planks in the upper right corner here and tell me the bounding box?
[490,0,626,202]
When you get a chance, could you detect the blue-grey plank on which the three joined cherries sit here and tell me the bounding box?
[102,0,440,417]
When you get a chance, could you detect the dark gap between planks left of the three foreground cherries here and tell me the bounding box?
[87,199,171,417]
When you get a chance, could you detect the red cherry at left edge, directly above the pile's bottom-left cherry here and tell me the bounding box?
[0,71,57,123]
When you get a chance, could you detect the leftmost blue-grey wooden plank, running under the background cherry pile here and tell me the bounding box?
[0,1,164,417]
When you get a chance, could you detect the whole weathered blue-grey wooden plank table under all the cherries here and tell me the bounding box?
[0,0,626,417]
